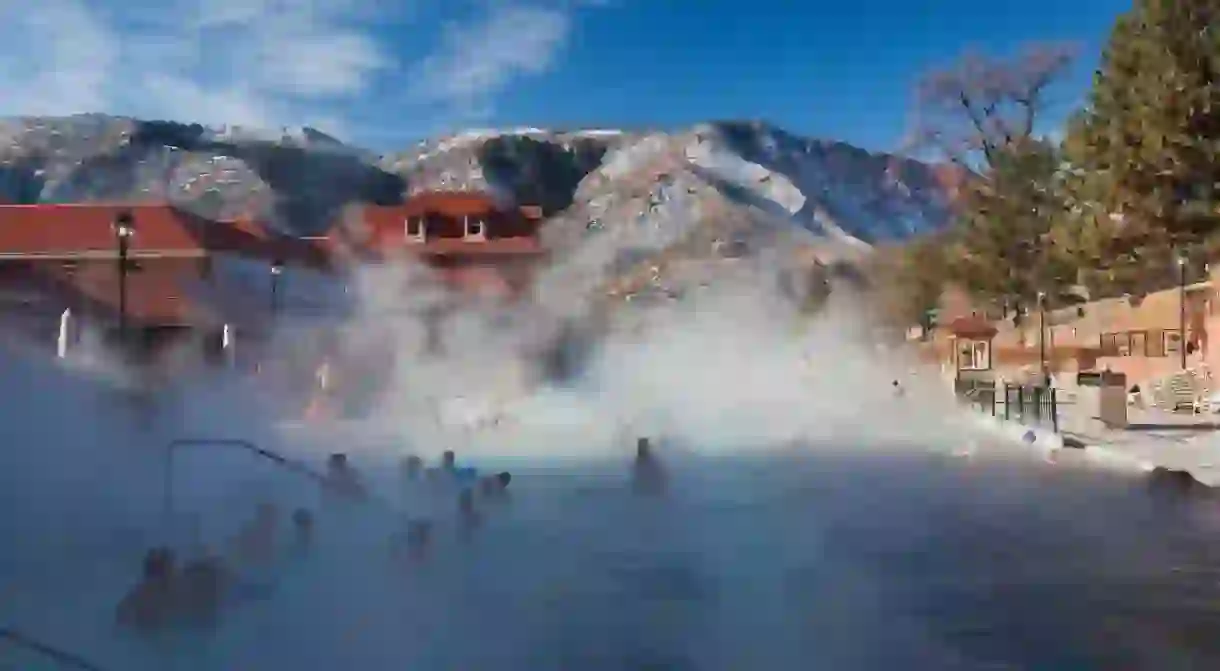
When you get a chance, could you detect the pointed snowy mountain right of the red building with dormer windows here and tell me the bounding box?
[539,123,952,314]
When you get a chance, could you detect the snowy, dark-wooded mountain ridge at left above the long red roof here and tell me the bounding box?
[0,115,404,233]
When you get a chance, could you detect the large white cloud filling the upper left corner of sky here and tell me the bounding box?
[0,0,394,131]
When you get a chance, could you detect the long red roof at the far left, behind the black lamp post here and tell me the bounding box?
[0,204,203,256]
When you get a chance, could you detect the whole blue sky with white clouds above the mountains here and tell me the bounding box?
[0,0,1131,150]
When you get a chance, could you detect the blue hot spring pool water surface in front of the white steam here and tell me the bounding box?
[0,450,1220,671]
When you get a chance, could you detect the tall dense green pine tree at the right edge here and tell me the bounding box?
[1065,0,1220,289]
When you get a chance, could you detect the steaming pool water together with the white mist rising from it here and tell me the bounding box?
[0,258,1220,670]
